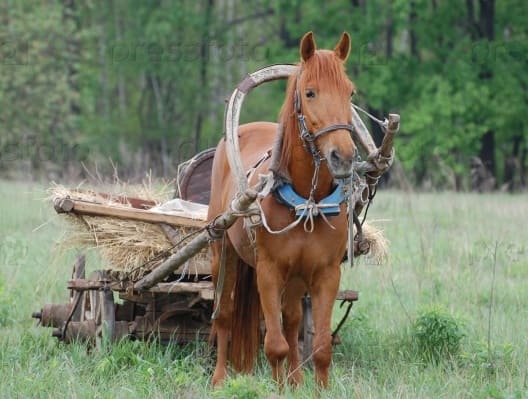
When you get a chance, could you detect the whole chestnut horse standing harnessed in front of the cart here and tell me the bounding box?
[209,32,356,387]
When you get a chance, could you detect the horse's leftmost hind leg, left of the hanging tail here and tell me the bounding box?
[211,240,238,387]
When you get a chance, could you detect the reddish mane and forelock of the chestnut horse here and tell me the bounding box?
[275,50,351,179]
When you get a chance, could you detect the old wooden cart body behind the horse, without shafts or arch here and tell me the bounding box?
[33,150,358,356]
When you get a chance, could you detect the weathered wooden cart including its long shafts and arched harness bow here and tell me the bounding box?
[33,65,399,359]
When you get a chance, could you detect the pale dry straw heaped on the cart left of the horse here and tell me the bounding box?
[50,185,207,281]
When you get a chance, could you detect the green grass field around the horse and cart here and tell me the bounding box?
[0,181,528,399]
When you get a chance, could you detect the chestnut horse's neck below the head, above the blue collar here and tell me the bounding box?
[285,124,333,202]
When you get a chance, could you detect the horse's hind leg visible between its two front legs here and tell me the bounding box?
[282,280,306,386]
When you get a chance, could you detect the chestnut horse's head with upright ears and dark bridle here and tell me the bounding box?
[295,32,356,178]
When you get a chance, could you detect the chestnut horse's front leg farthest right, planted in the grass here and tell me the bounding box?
[311,264,341,388]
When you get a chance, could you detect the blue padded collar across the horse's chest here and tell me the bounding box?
[274,182,345,216]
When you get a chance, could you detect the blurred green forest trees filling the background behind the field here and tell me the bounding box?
[0,0,528,189]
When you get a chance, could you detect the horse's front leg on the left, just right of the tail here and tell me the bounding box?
[257,259,289,386]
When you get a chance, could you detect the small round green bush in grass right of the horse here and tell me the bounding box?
[411,306,466,363]
